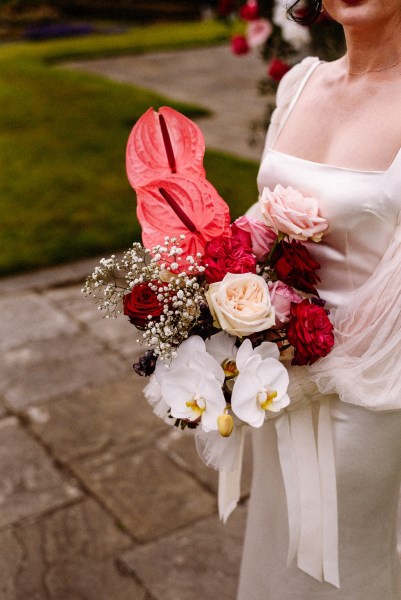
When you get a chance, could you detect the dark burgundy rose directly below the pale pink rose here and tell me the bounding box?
[272,240,320,296]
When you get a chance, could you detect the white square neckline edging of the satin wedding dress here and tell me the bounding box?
[267,57,401,175]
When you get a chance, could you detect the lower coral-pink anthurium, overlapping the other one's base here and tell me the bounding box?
[137,175,230,257]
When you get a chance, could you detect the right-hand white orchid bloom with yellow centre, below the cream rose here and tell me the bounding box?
[231,340,290,427]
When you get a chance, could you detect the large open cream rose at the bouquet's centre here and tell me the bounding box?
[206,273,275,337]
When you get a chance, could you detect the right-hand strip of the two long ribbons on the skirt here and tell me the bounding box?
[318,399,340,587]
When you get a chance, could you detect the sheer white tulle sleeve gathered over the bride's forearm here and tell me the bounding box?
[309,213,401,410]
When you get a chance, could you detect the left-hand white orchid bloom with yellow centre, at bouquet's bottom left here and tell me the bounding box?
[155,336,226,431]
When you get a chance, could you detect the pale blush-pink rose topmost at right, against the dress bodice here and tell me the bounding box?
[260,185,328,242]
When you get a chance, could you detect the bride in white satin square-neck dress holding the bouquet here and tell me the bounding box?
[238,0,401,600]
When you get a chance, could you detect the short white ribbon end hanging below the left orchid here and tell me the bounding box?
[217,427,245,523]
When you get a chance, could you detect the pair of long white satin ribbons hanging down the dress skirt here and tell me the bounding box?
[275,400,340,587]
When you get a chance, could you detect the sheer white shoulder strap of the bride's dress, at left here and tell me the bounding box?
[263,56,320,155]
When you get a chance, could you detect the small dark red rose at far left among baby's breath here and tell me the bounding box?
[123,283,163,329]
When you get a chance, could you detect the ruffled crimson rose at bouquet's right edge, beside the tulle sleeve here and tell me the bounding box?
[287,300,334,365]
